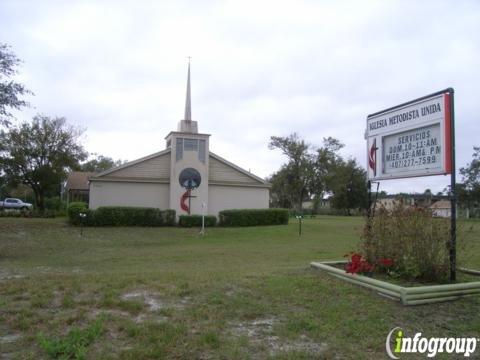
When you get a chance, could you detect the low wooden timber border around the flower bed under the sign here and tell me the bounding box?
[310,261,480,305]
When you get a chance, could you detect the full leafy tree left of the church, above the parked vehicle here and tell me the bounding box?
[0,115,87,210]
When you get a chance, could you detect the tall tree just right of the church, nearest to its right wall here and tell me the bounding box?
[269,133,313,212]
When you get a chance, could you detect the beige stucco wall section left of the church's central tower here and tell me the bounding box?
[90,181,170,210]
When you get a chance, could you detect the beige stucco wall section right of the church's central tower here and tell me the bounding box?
[207,185,269,215]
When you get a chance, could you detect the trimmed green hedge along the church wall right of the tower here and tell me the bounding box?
[218,209,289,226]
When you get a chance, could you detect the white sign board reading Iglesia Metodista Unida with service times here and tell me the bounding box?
[365,91,451,180]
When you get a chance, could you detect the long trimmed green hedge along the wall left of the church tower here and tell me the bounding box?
[68,202,175,226]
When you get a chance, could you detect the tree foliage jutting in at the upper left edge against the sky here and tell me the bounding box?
[0,43,33,126]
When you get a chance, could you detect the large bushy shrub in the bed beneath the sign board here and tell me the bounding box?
[361,204,450,282]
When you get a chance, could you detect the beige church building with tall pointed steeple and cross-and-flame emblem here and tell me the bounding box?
[89,64,270,215]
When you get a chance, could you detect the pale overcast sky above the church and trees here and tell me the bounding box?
[0,0,480,192]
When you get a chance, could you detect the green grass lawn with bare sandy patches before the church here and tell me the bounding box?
[0,217,480,359]
